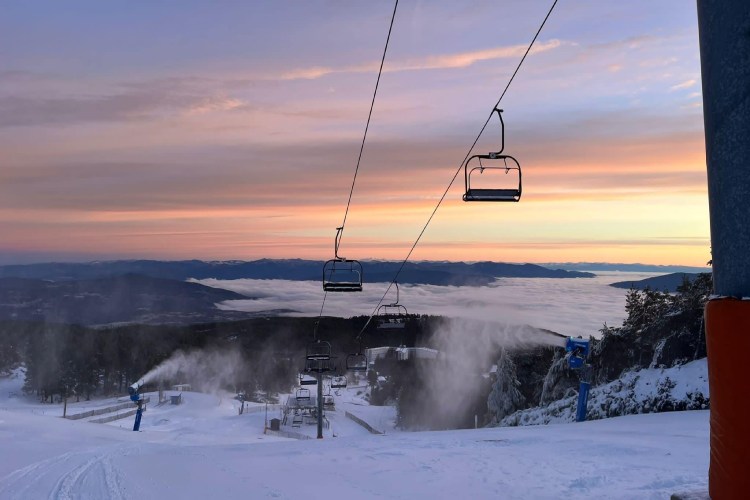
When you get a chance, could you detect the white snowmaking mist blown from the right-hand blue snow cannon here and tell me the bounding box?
[420,318,565,424]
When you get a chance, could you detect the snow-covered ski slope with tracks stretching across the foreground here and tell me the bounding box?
[0,370,708,499]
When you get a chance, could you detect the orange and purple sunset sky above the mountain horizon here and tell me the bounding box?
[0,0,710,266]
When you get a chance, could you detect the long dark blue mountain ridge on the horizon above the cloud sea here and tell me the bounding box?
[0,259,594,286]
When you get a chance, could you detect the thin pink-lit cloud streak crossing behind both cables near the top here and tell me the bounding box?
[281,40,563,80]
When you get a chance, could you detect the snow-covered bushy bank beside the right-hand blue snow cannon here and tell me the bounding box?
[500,358,709,426]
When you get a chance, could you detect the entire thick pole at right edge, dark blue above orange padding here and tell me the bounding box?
[697,0,750,499]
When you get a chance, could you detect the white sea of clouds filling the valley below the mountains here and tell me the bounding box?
[198,273,651,336]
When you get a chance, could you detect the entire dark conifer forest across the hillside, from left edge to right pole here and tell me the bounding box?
[0,274,711,429]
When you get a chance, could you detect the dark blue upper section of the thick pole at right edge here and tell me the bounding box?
[698,0,750,297]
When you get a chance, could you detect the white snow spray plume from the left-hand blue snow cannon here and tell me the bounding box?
[141,350,244,392]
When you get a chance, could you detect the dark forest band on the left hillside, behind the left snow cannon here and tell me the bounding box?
[0,316,438,402]
